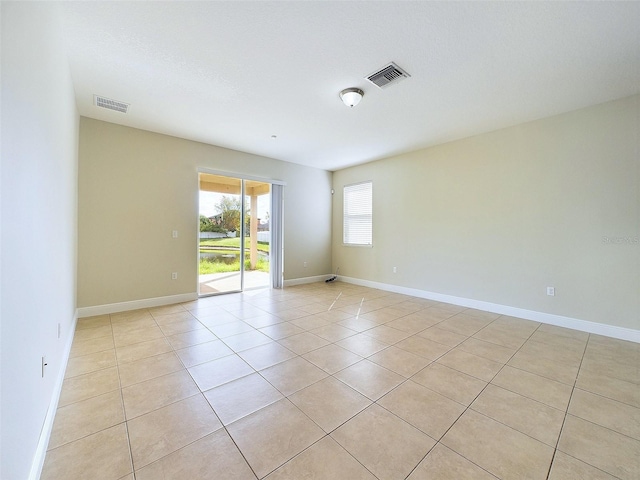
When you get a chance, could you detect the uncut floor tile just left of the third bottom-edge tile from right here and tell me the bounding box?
[377,381,466,440]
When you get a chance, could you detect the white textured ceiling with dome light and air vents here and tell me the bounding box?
[61,1,640,170]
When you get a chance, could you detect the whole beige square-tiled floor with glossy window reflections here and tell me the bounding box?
[42,282,640,480]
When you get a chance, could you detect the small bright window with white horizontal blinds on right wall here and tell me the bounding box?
[343,182,373,245]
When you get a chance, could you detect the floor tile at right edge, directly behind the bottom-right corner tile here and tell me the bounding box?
[569,386,640,440]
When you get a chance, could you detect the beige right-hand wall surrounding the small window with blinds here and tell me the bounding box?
[333,96,640,329]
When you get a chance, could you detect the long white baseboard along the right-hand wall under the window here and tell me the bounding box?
[339,275,640,343]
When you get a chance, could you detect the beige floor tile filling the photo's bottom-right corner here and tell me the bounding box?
[558,415,640,480]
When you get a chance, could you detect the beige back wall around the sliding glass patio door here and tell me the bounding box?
[78,117,331,307]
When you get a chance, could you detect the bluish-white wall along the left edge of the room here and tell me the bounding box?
[0,2,78,480]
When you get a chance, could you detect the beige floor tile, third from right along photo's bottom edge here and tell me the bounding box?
[441,410,554,480]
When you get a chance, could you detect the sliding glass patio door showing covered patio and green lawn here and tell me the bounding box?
[198,173,271,296]
